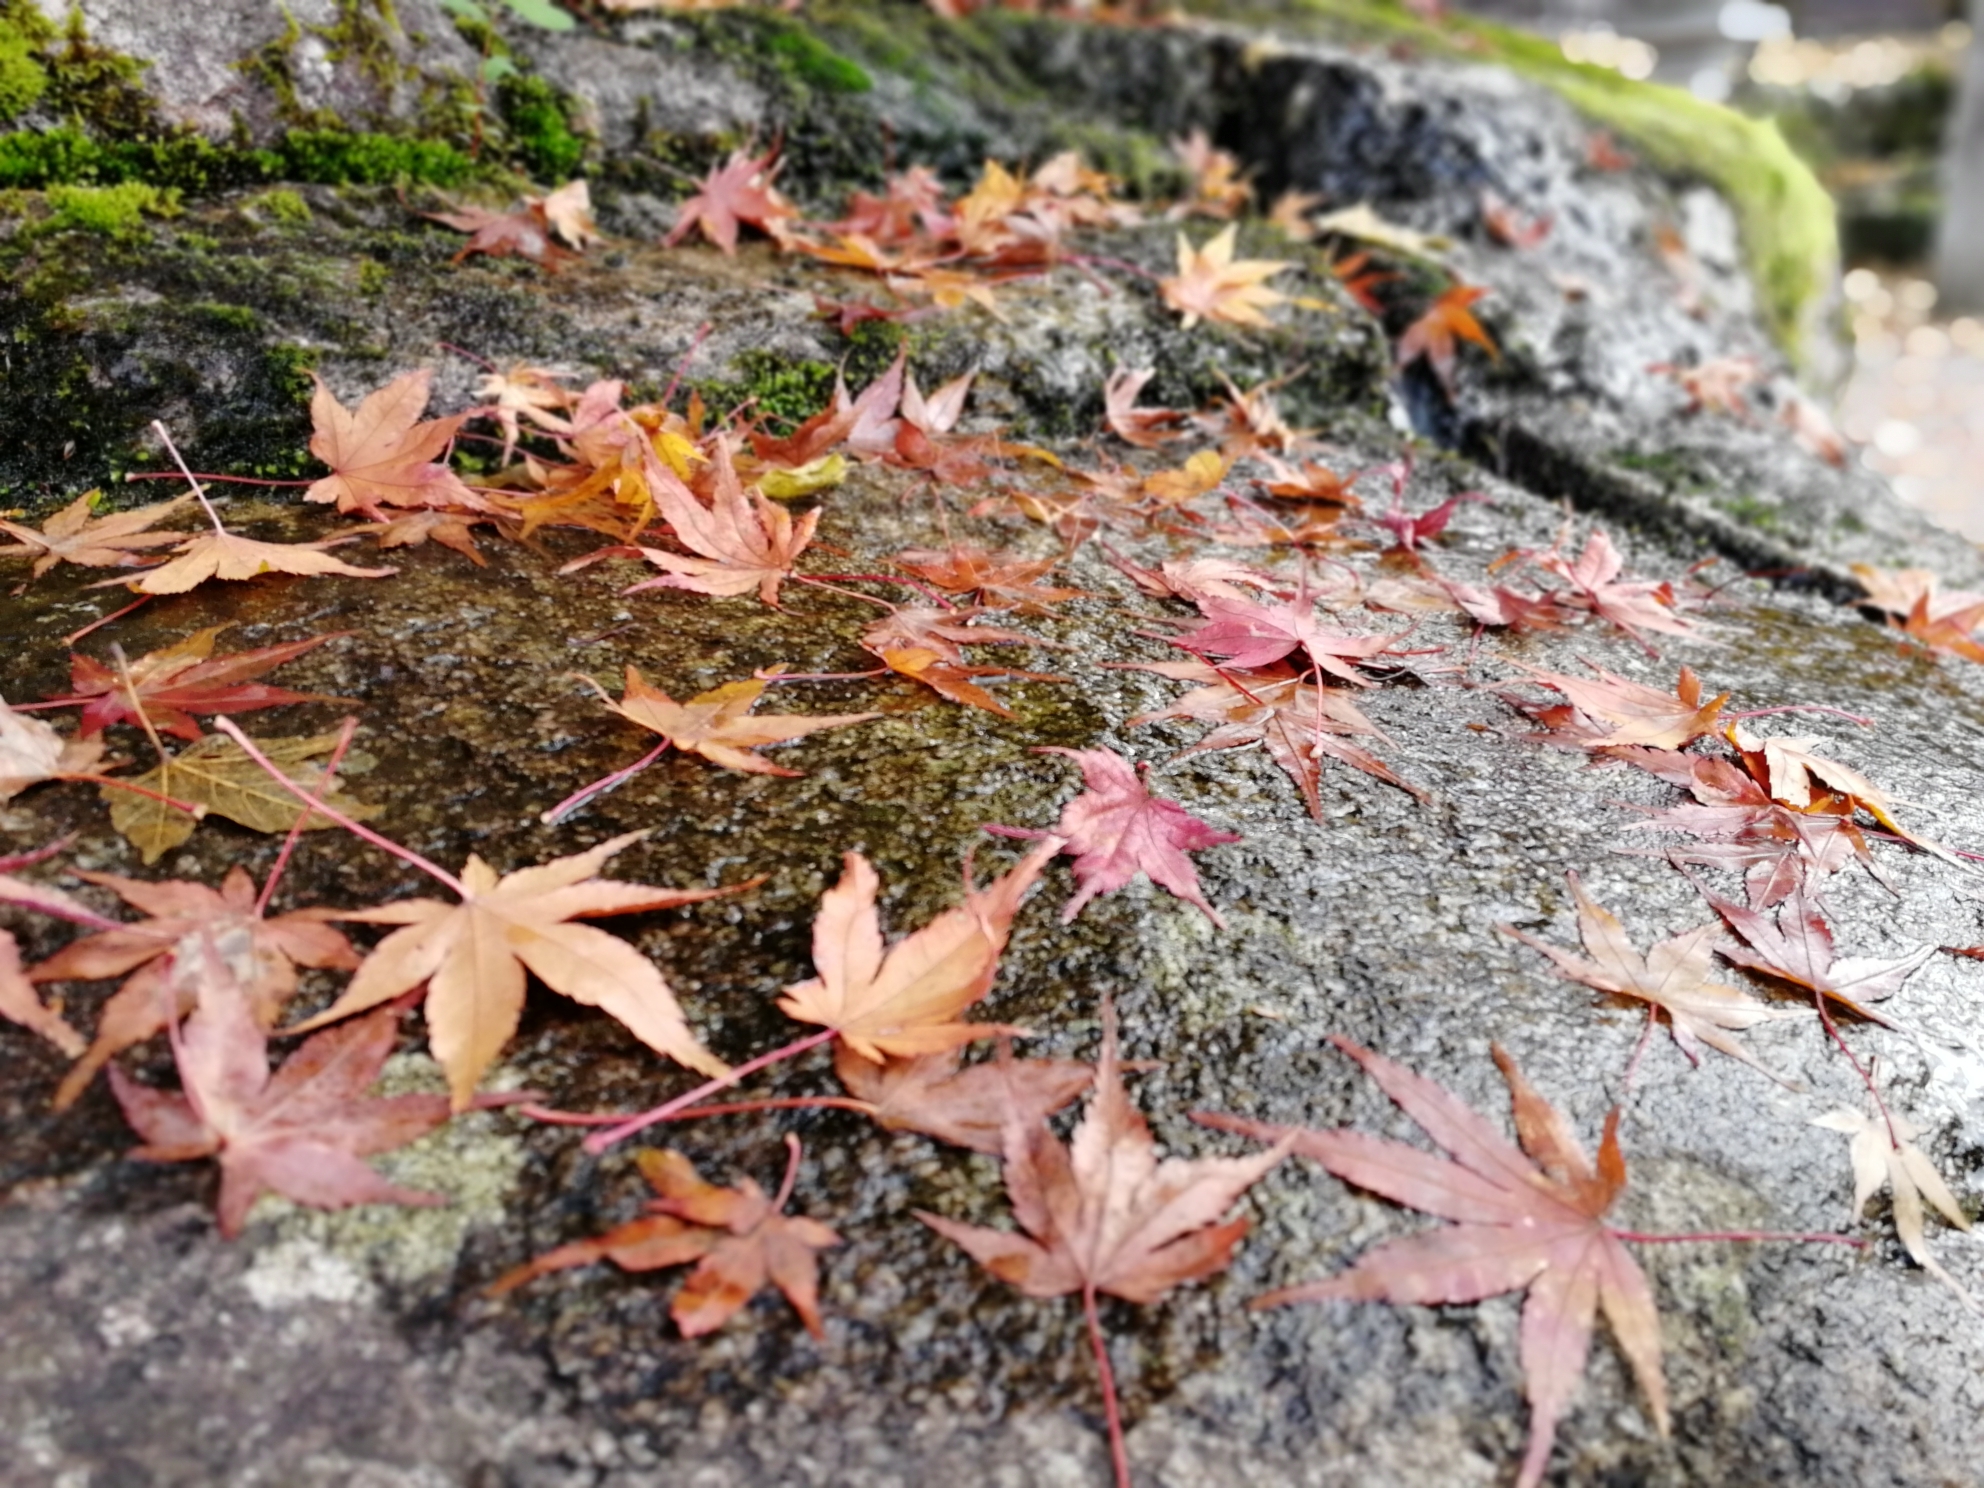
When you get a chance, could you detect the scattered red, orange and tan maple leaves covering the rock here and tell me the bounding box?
[0,87,1984,1484]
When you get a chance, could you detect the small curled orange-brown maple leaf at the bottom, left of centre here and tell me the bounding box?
[488,1137,841,1337]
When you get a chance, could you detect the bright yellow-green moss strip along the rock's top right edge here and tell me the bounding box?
[1294,0,1839,365]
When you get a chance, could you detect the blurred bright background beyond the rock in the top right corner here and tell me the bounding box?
[1452,0,1984,542]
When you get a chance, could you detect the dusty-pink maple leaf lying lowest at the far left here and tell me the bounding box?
[109,936,480,1240]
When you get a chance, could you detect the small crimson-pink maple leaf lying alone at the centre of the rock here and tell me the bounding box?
[986,744,1240,929]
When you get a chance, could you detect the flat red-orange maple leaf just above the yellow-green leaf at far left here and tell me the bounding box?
[32,625,353,740]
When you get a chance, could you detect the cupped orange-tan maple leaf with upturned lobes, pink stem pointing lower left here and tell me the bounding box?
[778,837,1061,1063]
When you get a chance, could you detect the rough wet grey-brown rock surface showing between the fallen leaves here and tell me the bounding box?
[0,0,1984,1488]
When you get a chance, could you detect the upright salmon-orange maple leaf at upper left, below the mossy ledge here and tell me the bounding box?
[304,367,490,520]
